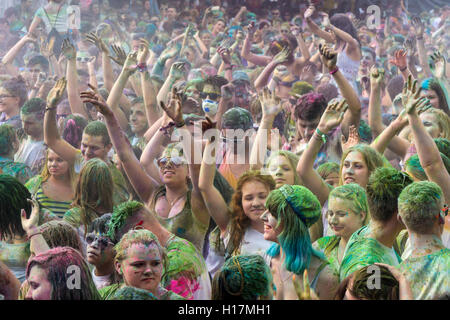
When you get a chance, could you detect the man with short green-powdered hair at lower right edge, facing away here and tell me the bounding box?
[398,181,450,300]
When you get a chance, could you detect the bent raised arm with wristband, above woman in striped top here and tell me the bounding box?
[44,78,79,164]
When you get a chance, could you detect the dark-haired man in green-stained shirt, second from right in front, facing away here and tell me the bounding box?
[339,168,413,281]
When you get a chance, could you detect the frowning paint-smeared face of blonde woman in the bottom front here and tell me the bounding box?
[116,243,163,293]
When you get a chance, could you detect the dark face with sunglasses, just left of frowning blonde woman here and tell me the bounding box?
[86,232,115,267]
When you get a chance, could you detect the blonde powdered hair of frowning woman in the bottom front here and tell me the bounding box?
[114,229,168,273]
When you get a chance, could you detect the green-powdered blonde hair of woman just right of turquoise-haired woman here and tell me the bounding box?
[328,183,370,226]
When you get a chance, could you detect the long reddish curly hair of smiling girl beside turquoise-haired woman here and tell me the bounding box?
[229,170,275,252]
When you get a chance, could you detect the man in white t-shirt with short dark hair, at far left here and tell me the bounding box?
[14,98,47,175]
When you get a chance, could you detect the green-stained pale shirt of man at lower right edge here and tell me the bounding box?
[398,248,450,300]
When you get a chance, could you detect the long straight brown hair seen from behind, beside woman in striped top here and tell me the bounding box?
[72,158,114,233]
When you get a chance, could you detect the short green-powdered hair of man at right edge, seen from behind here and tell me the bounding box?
[398,181,444,234]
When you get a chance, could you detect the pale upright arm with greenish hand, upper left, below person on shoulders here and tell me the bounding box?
[62,39,89,119]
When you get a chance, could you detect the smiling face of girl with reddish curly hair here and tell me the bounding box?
[242,180,269,221]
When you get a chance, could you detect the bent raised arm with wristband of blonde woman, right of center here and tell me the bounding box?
[297,100,347,205]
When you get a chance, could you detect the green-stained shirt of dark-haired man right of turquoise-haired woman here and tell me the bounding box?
[339,226,401,281]
